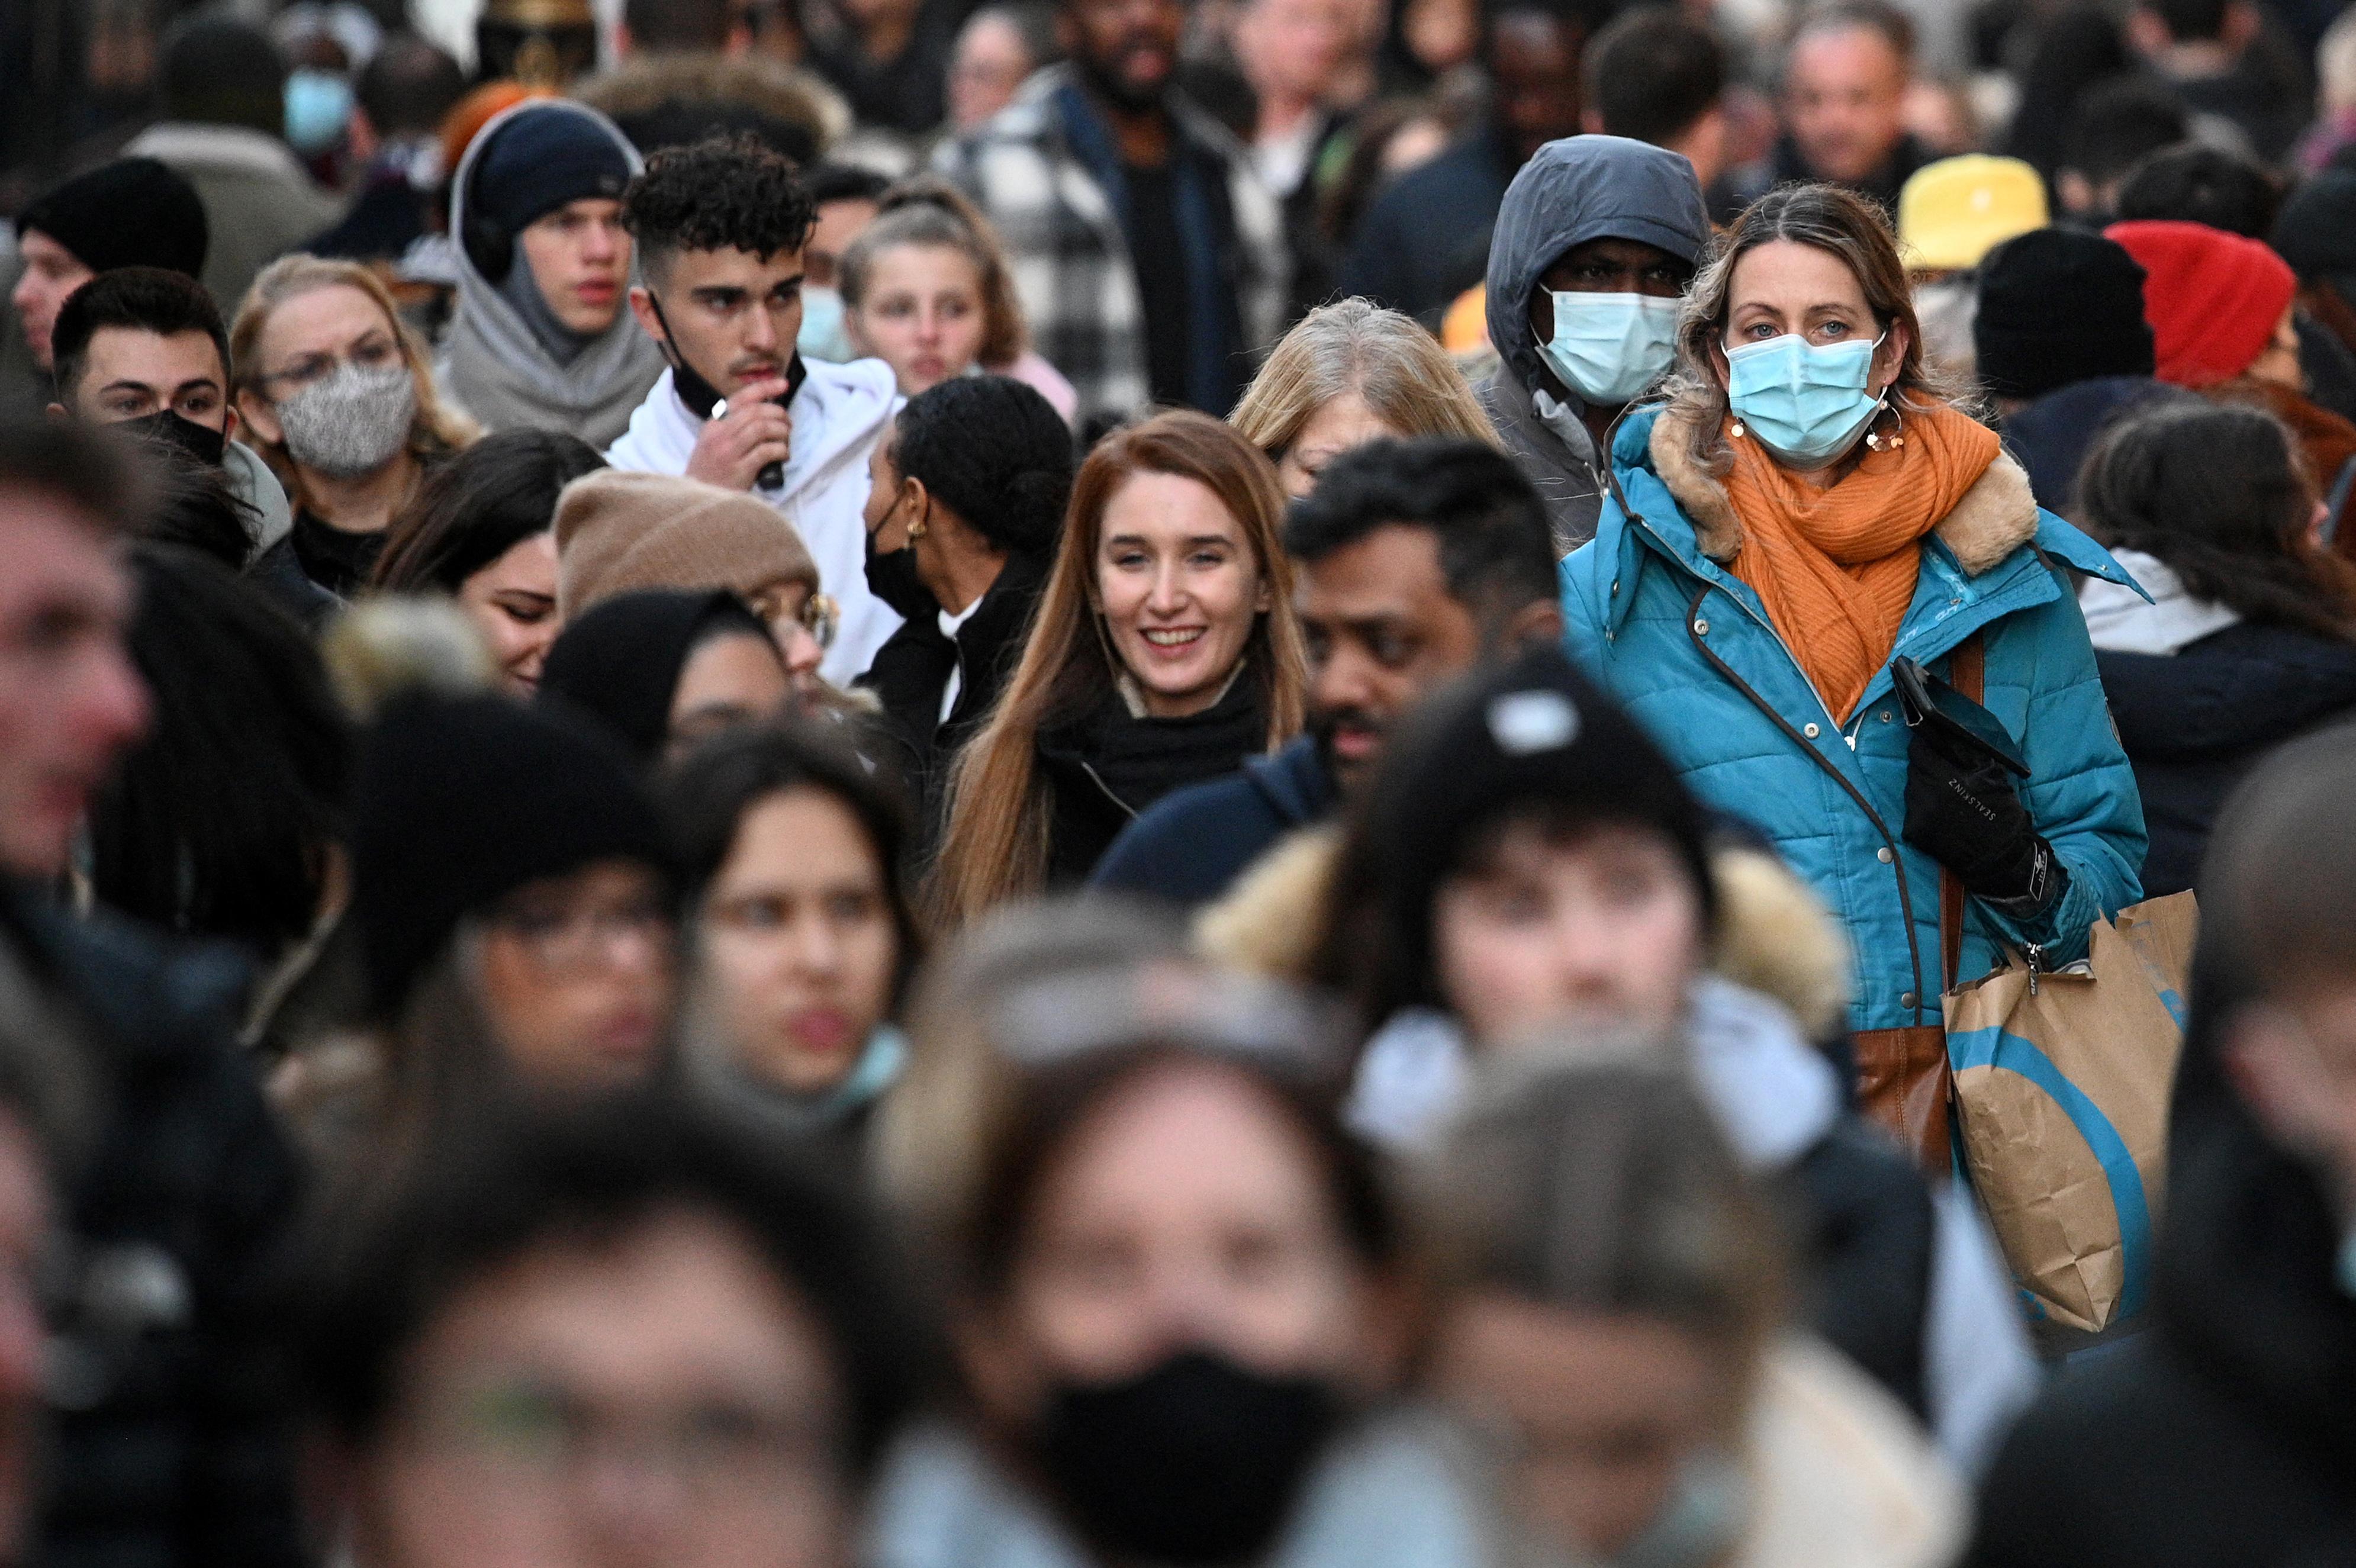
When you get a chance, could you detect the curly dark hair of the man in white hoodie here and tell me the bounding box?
[622,132,815,274]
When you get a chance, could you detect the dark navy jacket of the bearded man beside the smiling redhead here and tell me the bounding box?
[1089,735,1336,909]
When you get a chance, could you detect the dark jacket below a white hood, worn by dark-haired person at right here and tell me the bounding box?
[2094,624,2356,897]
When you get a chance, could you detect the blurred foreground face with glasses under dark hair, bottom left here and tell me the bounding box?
[353,1210,846,1568]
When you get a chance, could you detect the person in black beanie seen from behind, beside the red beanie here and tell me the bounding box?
[1972,228,2168,504]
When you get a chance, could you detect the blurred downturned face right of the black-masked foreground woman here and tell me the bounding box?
[1433,1290,1729,1561]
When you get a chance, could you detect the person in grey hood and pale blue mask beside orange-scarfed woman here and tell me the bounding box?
[1475,137,1710,556]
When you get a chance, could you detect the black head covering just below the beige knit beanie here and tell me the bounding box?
[539,588,768,763]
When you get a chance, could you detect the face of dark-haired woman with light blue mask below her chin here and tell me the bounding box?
[702,788,900,1095]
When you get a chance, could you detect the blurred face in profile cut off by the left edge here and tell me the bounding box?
[0,490,146,878]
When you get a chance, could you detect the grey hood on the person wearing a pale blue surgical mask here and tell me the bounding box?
[1489,137,1710,412]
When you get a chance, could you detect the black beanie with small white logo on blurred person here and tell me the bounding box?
[1364,648,1717,1005]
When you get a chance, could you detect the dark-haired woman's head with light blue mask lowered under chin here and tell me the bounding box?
[664,727,921,1149]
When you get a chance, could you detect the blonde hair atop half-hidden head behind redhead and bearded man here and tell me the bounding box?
[1228,299,1498,462]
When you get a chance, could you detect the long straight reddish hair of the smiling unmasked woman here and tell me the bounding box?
[928,410,1308,930]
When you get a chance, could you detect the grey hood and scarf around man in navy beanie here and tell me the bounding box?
[436,99,664,447]
